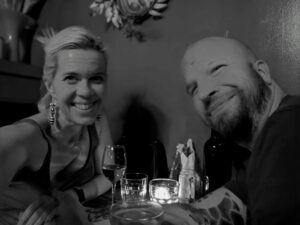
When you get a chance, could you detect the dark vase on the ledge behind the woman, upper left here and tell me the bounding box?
[0,9,37,63]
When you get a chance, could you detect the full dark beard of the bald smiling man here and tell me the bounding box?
[212,74,271,142]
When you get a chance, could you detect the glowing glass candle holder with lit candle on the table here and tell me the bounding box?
[149,178,179,204]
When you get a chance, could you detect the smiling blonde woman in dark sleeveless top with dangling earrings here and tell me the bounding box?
[0,27,111,224]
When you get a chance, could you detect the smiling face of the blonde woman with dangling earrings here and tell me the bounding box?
[46,49,106,126]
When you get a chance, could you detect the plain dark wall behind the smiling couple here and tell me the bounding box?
[31,0,300,167]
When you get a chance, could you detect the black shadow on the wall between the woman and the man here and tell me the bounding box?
[119,96,168,180]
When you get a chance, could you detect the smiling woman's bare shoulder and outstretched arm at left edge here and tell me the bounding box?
[0,124,47,190]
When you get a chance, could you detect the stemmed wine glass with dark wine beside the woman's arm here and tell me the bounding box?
[102,145,127,204]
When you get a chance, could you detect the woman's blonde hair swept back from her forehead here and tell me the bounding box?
[36,26,107,111]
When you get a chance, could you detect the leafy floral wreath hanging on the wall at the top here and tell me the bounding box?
[90,0,168,41]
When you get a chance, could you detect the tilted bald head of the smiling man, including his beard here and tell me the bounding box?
[183,39,269,141]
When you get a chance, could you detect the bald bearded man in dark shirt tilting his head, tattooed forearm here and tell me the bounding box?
[166,37,300,225]
